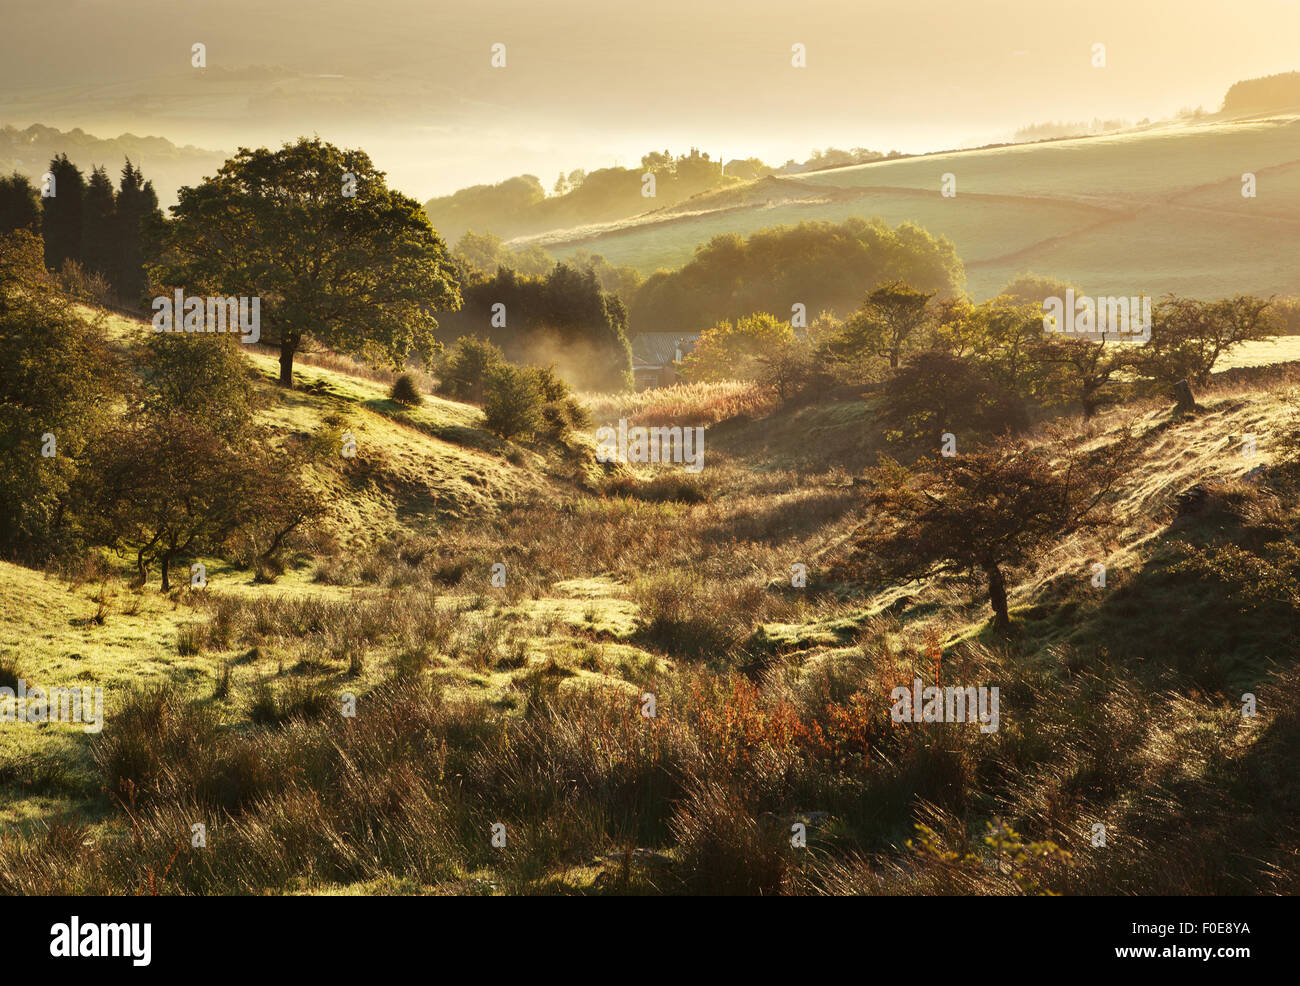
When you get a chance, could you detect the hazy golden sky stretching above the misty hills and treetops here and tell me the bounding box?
[0,0,1300,198]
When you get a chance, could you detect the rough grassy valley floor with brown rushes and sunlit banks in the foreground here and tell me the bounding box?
[0,305,1300,894]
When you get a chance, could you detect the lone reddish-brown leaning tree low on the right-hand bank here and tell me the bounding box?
[840,437,1131,631]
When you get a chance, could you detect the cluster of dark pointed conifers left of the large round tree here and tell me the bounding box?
[0,153,163,308]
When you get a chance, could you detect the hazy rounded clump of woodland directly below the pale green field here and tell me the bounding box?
[629,217,966,333]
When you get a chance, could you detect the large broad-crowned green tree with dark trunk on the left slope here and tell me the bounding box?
[152,138,460,388]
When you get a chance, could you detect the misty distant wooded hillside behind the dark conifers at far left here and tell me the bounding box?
[0,124,228,207]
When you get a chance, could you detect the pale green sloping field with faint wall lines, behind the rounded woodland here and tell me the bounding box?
[520,117,1300,297]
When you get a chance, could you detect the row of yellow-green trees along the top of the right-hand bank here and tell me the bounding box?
[684,277,1286,437]
